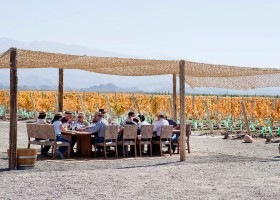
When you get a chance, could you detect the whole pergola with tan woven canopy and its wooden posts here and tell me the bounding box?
[0,48,280,169]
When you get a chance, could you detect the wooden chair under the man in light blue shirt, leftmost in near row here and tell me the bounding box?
[94,125,119,159]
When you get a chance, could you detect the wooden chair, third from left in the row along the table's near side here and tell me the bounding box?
[138,125,154,156]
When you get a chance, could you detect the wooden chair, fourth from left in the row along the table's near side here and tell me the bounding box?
[152,125,173,156]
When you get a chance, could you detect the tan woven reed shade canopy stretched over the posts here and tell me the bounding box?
[0,49,280,90]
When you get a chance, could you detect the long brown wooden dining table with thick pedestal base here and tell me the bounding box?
[62,131,92,158]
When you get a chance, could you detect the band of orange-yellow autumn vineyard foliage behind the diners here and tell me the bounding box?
[0,90,280,136]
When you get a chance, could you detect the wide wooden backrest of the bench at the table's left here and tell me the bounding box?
[26,124,56,140]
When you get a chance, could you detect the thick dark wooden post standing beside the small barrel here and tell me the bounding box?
[9,48,18,170]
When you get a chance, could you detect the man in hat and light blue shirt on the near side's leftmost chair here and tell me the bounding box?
[85,112,106,154]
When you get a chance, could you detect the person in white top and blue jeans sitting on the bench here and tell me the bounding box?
[42,112,71,159]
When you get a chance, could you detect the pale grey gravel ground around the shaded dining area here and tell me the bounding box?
[0,122,280,200]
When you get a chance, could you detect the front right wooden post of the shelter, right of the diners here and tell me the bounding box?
[179,60,186,161]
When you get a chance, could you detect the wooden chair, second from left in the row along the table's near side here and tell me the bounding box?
[118,125,138,157]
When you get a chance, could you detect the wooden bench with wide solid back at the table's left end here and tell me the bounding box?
[26,124,71,158]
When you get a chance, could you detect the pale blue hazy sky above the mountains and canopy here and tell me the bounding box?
[0,0,280,67]
